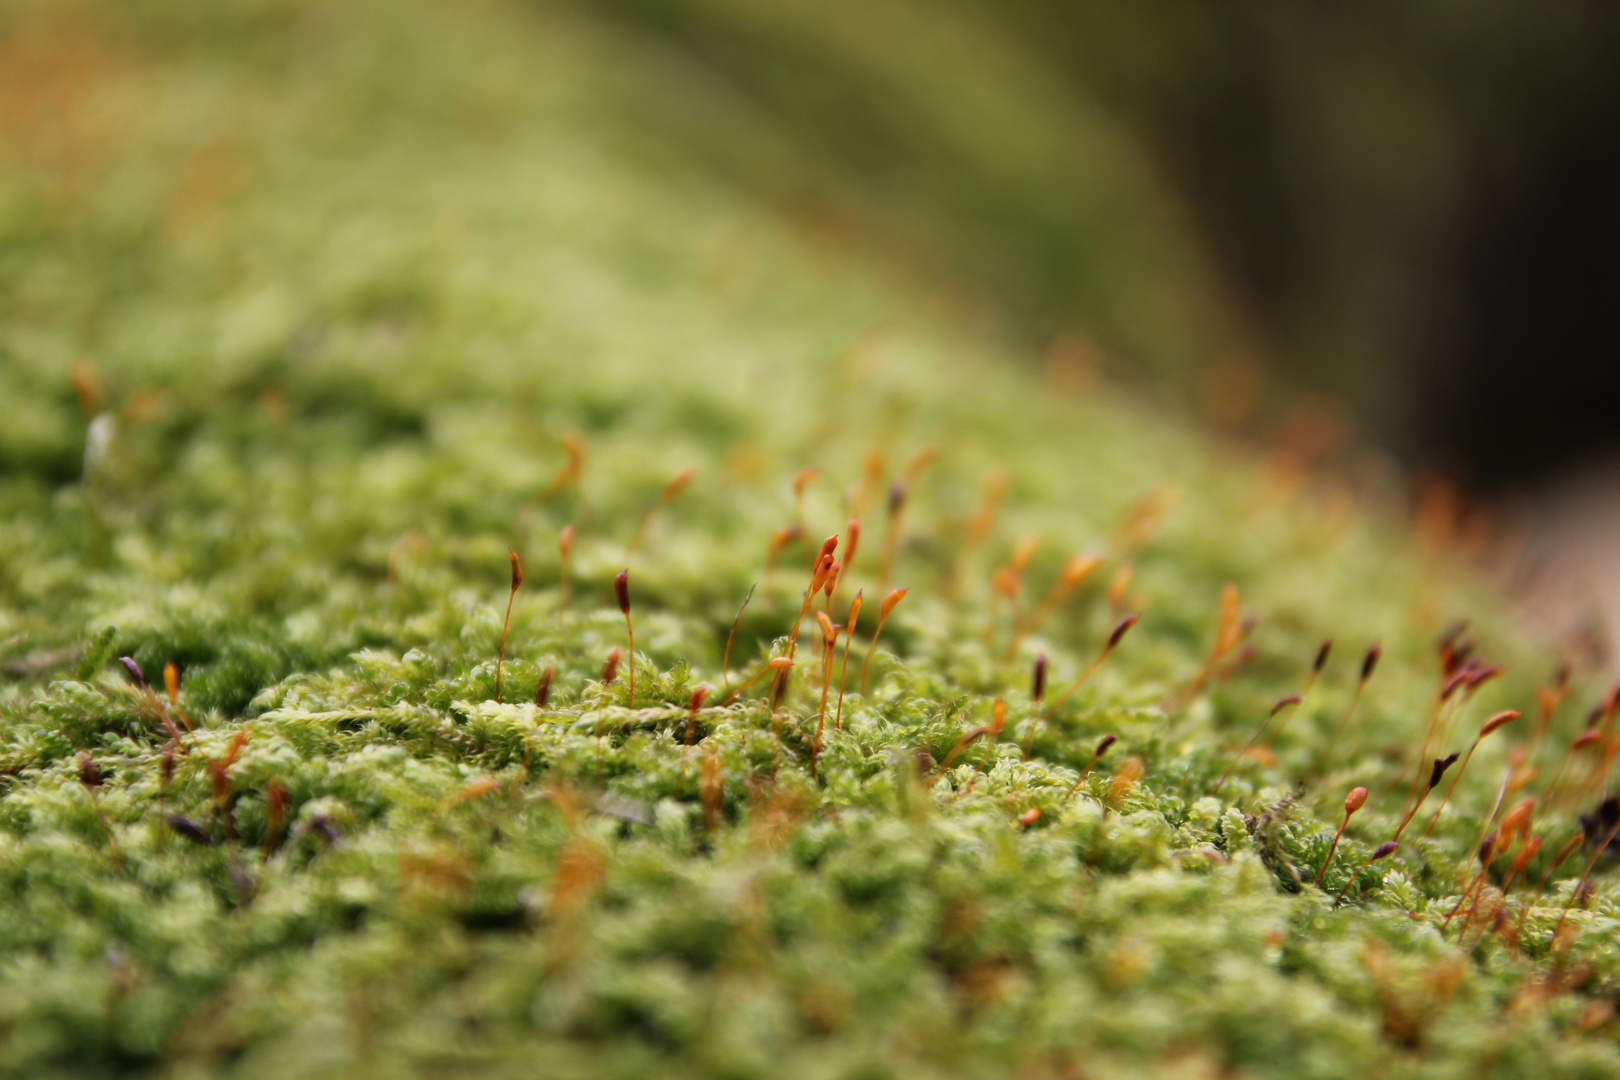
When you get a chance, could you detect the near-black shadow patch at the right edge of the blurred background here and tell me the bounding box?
[1414,116,1620,484]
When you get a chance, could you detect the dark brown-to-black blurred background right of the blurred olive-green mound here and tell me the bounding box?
[997,0,1620,487]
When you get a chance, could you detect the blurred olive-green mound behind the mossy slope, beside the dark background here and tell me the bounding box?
[598,0,1257,385]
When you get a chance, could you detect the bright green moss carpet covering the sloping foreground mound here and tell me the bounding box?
[0,3,1620,1078]
